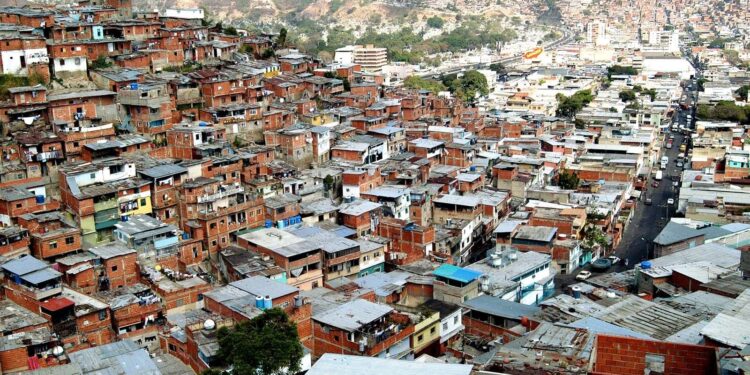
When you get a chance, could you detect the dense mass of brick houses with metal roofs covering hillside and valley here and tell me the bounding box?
[0,0,750,375]
